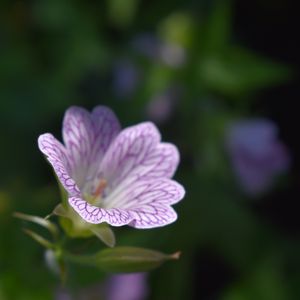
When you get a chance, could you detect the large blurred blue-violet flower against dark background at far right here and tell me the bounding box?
[226,119,290,195]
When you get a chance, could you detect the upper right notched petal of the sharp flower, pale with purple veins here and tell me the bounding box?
[101,123,179,188]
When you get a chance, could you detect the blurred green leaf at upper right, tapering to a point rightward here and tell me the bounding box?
[199,47,291,96]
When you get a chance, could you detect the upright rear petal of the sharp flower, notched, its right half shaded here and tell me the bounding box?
[63,106,120,187]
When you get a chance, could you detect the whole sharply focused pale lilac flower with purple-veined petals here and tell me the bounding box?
[38,106,185,228]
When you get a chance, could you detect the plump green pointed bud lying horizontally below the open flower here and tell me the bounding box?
[94,247,180,273]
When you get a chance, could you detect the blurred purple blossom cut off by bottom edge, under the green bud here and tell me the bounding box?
[106,273,149,300]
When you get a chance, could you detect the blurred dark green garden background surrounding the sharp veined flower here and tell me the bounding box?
[0,0,300,300]
